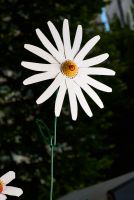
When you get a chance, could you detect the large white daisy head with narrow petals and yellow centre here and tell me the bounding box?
[21,19,115,120]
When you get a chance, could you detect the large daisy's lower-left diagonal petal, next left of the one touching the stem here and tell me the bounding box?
[36,73,64,104]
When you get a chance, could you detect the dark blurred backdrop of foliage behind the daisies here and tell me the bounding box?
[0,0,134,200]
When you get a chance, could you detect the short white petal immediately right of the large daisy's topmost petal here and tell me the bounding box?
[71,25,82,59]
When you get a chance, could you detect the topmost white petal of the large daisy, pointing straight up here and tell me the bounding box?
[63,19,71,59]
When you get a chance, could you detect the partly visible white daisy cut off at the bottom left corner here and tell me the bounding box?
[0,171,23,200]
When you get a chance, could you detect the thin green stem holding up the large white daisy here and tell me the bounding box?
[50,117,57,200]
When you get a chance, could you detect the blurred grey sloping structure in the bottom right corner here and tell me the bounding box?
[58,172,134,200]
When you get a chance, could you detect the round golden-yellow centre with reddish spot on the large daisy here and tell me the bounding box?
[61,60,78,78]
